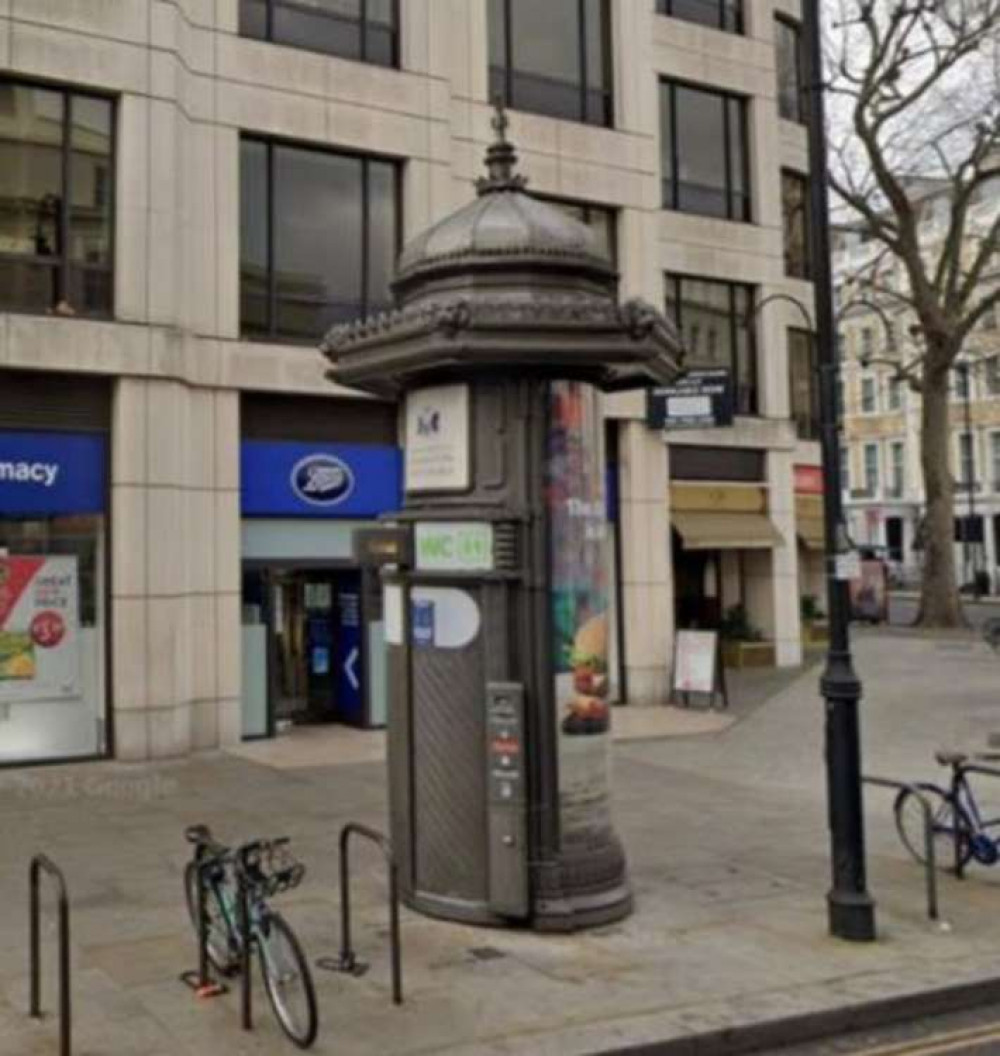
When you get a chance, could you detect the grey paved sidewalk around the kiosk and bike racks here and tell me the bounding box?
[0,636,1000,1056]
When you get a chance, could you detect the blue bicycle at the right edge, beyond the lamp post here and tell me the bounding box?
[893,752,1000,875]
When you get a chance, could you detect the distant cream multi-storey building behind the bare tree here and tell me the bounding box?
[834,177,1000,590]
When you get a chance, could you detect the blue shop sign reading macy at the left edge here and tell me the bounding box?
[0,430,108,516]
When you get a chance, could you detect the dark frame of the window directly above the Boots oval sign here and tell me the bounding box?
[238,132,403,345]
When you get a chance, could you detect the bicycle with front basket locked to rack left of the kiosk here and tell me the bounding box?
[184,825,319,1049]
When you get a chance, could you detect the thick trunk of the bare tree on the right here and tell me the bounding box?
[917,367,965,627]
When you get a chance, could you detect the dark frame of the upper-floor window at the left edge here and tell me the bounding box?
[0,77,119,320]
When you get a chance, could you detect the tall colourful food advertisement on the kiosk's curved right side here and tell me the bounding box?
[546,381,610,840]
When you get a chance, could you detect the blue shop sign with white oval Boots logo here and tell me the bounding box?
[240,440,402,517]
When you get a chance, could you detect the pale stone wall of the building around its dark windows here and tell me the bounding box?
[0,0,809,759]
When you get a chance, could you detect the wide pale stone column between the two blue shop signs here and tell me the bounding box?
[111,378,240,760]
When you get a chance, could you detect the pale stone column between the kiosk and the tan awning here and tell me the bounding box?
[619,421,674,704]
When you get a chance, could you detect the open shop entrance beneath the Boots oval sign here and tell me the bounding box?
[243,566,371,737]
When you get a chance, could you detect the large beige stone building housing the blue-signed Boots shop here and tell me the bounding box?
[0,0,822,763]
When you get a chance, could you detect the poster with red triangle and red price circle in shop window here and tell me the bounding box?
[0,555,80,704]
